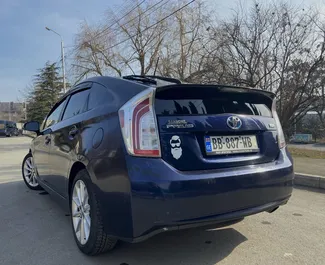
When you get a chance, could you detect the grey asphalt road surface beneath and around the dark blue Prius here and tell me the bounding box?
[0,137,325,265]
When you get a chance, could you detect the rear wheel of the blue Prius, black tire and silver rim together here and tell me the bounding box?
[70,169,117,256]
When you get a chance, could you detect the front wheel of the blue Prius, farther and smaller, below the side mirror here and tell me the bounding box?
[21,153,42,190]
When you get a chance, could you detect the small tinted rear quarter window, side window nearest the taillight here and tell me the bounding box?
[88,83,113,110]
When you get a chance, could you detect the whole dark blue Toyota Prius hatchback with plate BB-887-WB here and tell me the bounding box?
[22,76,294,255]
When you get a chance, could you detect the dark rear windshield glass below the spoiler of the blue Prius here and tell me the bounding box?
[155,86,272,117]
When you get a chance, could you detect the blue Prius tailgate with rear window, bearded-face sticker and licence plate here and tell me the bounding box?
[155,85,279,171]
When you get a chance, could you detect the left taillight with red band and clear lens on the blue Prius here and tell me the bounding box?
[119,88,161,157]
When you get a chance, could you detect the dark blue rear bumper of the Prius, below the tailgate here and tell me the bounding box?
[122,147,294,242]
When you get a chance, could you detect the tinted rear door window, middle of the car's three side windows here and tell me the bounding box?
[62,89,89,120]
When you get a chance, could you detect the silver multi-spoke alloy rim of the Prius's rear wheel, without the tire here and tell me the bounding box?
[71,180,91,245]
